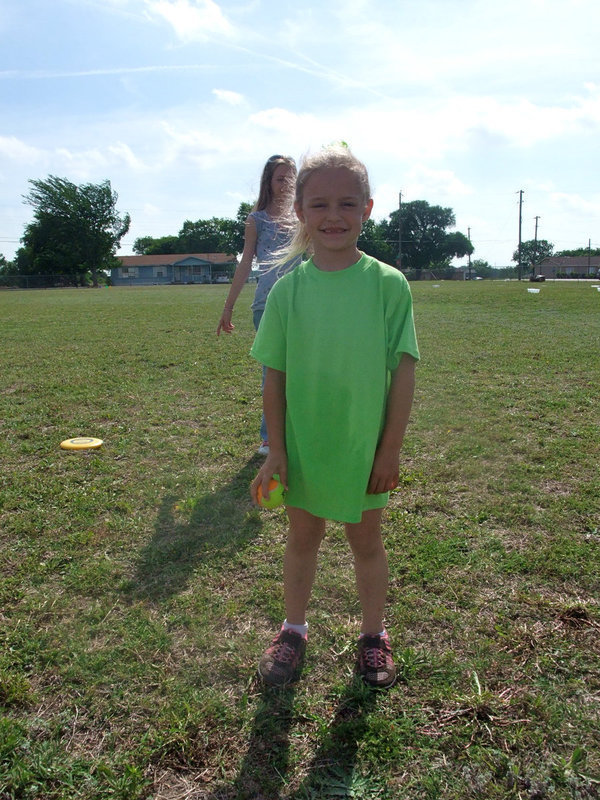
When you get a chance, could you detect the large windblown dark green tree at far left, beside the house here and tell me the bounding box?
[18,175,131,286]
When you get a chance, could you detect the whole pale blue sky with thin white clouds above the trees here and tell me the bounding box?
[0,0,600,266]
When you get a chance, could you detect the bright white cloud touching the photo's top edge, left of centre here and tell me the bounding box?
[145,0,234,43]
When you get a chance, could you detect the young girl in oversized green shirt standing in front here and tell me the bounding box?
[251,147,419,688]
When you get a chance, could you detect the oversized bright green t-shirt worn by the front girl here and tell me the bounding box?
[251,255,419,522]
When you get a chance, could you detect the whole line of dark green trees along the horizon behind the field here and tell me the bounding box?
[0,175,600,286]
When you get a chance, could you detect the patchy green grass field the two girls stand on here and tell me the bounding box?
[0,281,600,800]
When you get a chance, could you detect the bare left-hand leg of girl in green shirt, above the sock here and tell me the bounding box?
[283,506,325,625]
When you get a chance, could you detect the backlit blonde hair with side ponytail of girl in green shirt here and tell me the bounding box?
[277,144,371,263]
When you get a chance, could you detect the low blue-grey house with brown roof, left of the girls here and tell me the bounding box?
[110,253,237,286]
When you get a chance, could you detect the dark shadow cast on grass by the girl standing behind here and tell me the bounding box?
[125,457,262,601]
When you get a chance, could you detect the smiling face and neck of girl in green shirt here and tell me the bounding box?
[295,167,373,270]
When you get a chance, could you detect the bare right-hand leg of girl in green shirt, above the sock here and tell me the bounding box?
[345,508,389,634]
